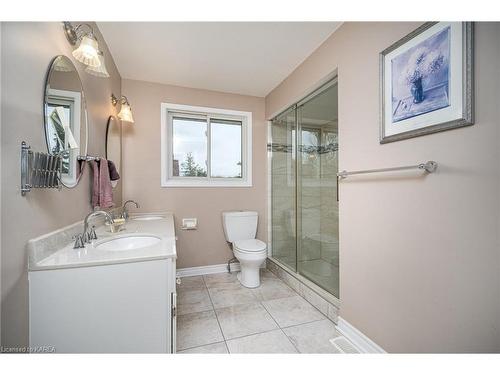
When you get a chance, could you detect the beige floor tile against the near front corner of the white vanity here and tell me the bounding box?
[177,311,224,350]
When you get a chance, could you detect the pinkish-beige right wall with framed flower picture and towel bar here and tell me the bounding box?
[266,23,500,352]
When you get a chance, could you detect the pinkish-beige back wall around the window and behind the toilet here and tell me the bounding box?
[122,80,267,268]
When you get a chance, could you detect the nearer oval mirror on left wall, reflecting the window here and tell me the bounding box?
[44,55,88,187]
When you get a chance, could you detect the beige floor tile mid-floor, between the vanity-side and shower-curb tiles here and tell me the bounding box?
[215,302,278,340]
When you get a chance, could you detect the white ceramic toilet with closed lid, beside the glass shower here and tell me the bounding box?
[222,211,267,288]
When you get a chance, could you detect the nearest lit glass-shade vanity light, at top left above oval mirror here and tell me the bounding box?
[63,22,101,68]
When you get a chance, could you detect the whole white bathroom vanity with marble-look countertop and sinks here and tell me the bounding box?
[28,213,176,353]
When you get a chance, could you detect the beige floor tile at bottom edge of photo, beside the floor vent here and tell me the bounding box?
[283,319,339,353]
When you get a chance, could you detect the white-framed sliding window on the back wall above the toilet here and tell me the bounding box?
[161,103,252,187]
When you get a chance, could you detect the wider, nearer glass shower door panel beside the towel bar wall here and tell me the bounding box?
[297,82,339,297]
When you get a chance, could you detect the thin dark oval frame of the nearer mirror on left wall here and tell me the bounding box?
[42,55,89,189]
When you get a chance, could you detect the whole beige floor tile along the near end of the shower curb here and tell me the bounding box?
[262,296,325,328]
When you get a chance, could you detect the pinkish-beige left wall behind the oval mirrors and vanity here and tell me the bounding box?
[1,22,121,347]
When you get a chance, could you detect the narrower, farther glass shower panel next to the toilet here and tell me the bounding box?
[271,107,297,271]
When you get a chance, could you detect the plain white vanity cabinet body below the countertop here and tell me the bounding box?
[29,259,175,353]
